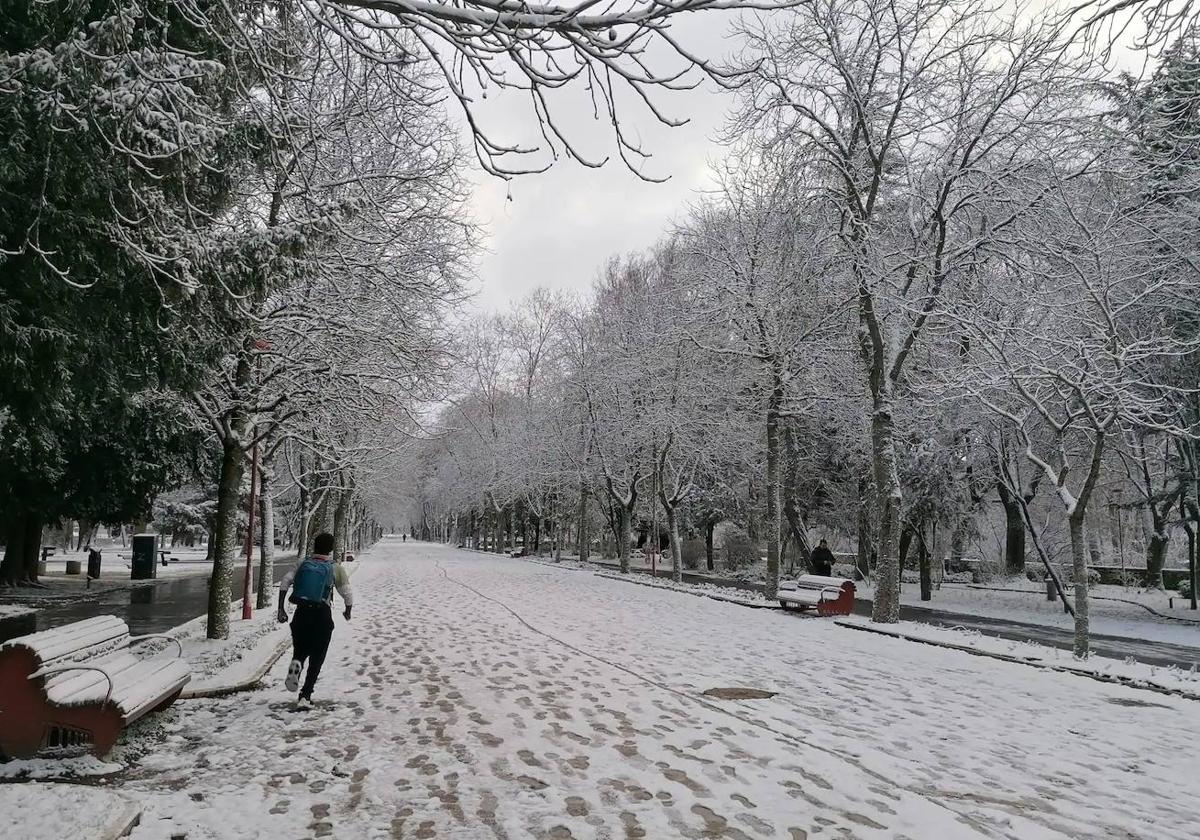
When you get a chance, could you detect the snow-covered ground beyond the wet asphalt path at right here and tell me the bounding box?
[857,583,1200,648]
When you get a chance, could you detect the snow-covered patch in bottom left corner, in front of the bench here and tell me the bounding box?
[0,777,142,840]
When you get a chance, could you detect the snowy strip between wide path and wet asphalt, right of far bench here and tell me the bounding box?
[836,616,1200,701]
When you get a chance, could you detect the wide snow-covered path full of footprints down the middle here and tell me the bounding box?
[116,542,1200,840]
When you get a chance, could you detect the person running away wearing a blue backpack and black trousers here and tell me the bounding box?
[278,534,354,709]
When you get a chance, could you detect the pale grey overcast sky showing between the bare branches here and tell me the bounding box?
[460,13,732,311]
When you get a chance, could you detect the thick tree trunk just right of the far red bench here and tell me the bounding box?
[871,397,902,624]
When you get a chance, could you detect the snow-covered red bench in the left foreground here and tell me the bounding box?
[0,616,191,758]
